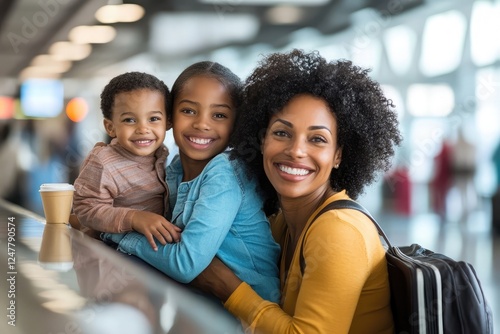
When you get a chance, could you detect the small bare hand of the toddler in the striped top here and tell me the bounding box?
[132,211,181,251]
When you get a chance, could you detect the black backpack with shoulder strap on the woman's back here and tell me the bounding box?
[300,200,493,334]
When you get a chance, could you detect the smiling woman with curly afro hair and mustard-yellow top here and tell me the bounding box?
[194,50,402,334]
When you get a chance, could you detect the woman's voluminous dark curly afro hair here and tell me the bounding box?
[230,49,402,213]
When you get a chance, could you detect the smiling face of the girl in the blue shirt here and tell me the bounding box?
[172,76,236,163]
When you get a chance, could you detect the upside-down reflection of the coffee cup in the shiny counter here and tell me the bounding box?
[38,224,73,271]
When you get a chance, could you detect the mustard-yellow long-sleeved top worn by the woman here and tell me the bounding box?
[224,191,394,334]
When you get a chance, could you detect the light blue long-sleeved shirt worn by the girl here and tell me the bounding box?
[105,152,280,302]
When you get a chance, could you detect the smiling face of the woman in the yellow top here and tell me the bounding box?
[262,95,342,199]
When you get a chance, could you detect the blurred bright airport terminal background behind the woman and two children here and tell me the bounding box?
[0,0,500,328]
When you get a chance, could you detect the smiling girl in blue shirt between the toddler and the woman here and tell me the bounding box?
[104,62,280,302]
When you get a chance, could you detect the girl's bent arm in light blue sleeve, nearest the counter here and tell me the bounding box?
[106,159,243,283]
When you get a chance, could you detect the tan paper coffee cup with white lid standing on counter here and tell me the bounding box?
[40,183,75,224]
